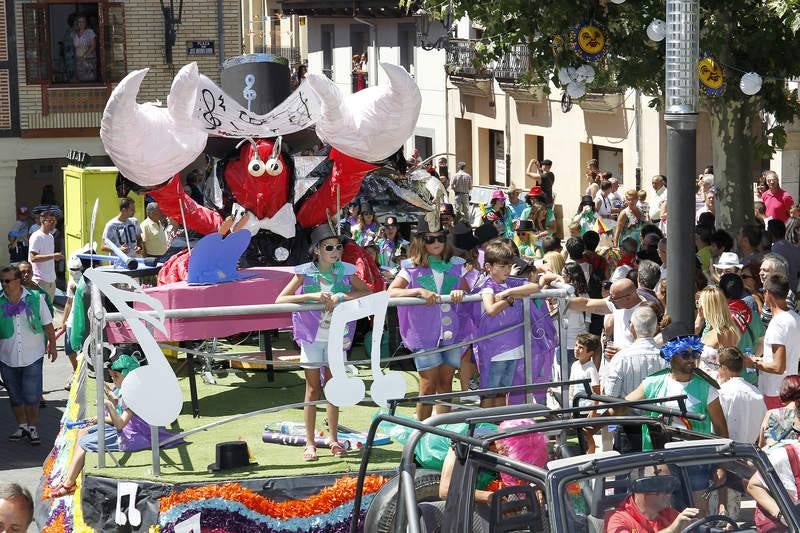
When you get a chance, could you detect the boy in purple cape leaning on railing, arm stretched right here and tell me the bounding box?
[473,241,555,407]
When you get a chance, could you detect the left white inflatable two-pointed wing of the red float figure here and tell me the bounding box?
[100,63,208,187]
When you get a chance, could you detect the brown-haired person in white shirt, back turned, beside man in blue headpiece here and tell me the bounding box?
[719,347,767,444]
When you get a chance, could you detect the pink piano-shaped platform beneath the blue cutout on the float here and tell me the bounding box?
[106,267,294,343]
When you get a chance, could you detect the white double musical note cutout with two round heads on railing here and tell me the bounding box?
[325,291,406,407]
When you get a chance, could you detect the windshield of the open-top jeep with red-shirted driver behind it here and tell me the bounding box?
[556,454,757,533]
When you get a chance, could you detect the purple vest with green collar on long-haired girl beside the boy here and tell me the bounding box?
[397,257,464,352]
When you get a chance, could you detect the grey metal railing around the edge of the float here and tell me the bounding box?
[90,285,574,477]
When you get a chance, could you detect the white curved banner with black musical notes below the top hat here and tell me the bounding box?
[193,74,321,138]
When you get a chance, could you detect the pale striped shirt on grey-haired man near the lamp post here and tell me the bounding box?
[602,337,667,398]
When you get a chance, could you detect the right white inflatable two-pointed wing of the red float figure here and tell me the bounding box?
[306,63,422,161]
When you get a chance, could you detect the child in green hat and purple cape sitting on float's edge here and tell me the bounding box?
[52,354,183,498]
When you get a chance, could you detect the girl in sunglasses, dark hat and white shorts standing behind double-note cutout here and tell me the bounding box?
[275,224,371,461]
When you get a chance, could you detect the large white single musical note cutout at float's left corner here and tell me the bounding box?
[83,268,183,426]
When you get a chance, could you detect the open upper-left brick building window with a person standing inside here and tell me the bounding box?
[22,1,127,85]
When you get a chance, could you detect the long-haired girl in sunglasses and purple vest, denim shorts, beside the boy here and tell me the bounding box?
[389,220,467,420]
